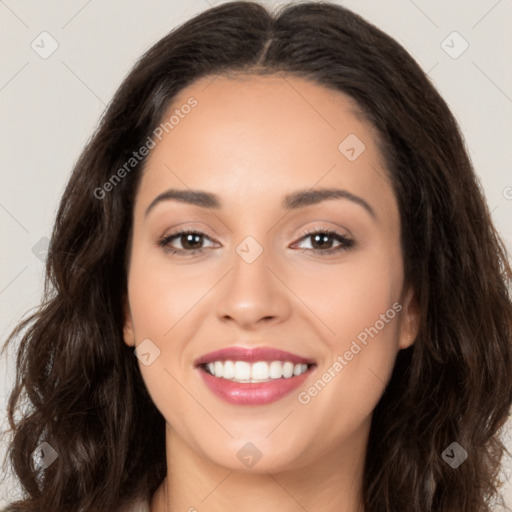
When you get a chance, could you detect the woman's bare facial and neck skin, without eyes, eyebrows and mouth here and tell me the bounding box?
[124,75,418,512]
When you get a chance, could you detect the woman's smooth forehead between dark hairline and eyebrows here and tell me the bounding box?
[135,75,394,222]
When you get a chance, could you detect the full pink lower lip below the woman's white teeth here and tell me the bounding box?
[197,366,314,405]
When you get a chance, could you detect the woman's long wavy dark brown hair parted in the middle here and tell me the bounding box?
[3,2,512,512]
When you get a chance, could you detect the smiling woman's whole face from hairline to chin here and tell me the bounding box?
[124,76,417,472]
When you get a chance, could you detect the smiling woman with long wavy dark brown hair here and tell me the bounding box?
[1,2,512,512]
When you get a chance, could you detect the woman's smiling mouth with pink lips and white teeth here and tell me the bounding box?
[195,347,317,405]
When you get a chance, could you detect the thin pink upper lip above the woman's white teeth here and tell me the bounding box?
[194,346,315,366]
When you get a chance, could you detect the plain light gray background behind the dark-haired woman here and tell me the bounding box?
[0,0,512,510]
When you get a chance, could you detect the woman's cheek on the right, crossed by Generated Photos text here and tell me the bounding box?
[292,248,403,428]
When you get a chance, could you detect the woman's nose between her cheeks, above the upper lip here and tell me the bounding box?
[216,242,291,330]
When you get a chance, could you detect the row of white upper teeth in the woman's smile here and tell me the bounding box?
[206,361,308,382]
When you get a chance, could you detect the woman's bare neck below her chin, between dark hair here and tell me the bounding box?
[151,425,368,512]
